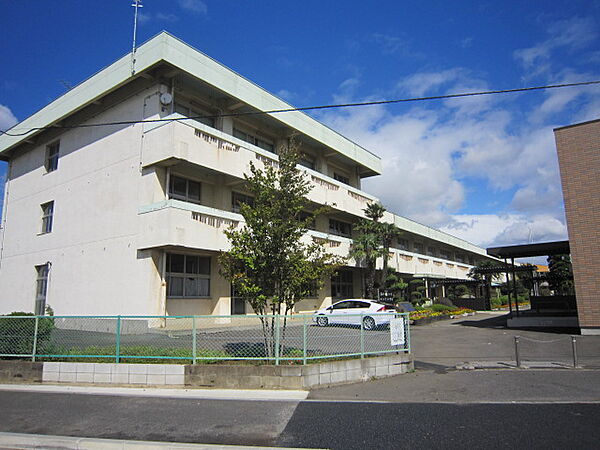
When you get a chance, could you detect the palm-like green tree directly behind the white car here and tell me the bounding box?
[350,202,401,298]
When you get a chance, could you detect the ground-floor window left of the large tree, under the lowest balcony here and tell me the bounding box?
[166,253,210,298]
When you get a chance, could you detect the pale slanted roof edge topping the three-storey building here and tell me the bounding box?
[0,31,381,175]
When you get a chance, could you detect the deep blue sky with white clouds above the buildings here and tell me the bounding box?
[0,0,600,250]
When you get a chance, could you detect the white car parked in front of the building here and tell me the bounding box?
[313,298,396,330]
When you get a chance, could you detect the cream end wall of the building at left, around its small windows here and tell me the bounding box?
[0,88,164,315]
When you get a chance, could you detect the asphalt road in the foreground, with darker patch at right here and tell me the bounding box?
[0,391,600,449]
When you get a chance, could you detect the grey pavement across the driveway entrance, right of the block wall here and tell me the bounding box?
[308,364,600,404]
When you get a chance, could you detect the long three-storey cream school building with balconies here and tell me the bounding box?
[0,33,488,315]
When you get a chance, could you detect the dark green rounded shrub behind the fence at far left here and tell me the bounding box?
[0,311,55,355]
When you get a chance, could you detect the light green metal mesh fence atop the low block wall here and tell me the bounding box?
[0,312,410,364]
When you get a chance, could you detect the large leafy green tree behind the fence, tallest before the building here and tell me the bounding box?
[219,139,344,357]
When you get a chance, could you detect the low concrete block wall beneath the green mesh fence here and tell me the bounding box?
[0,353,414,389]
